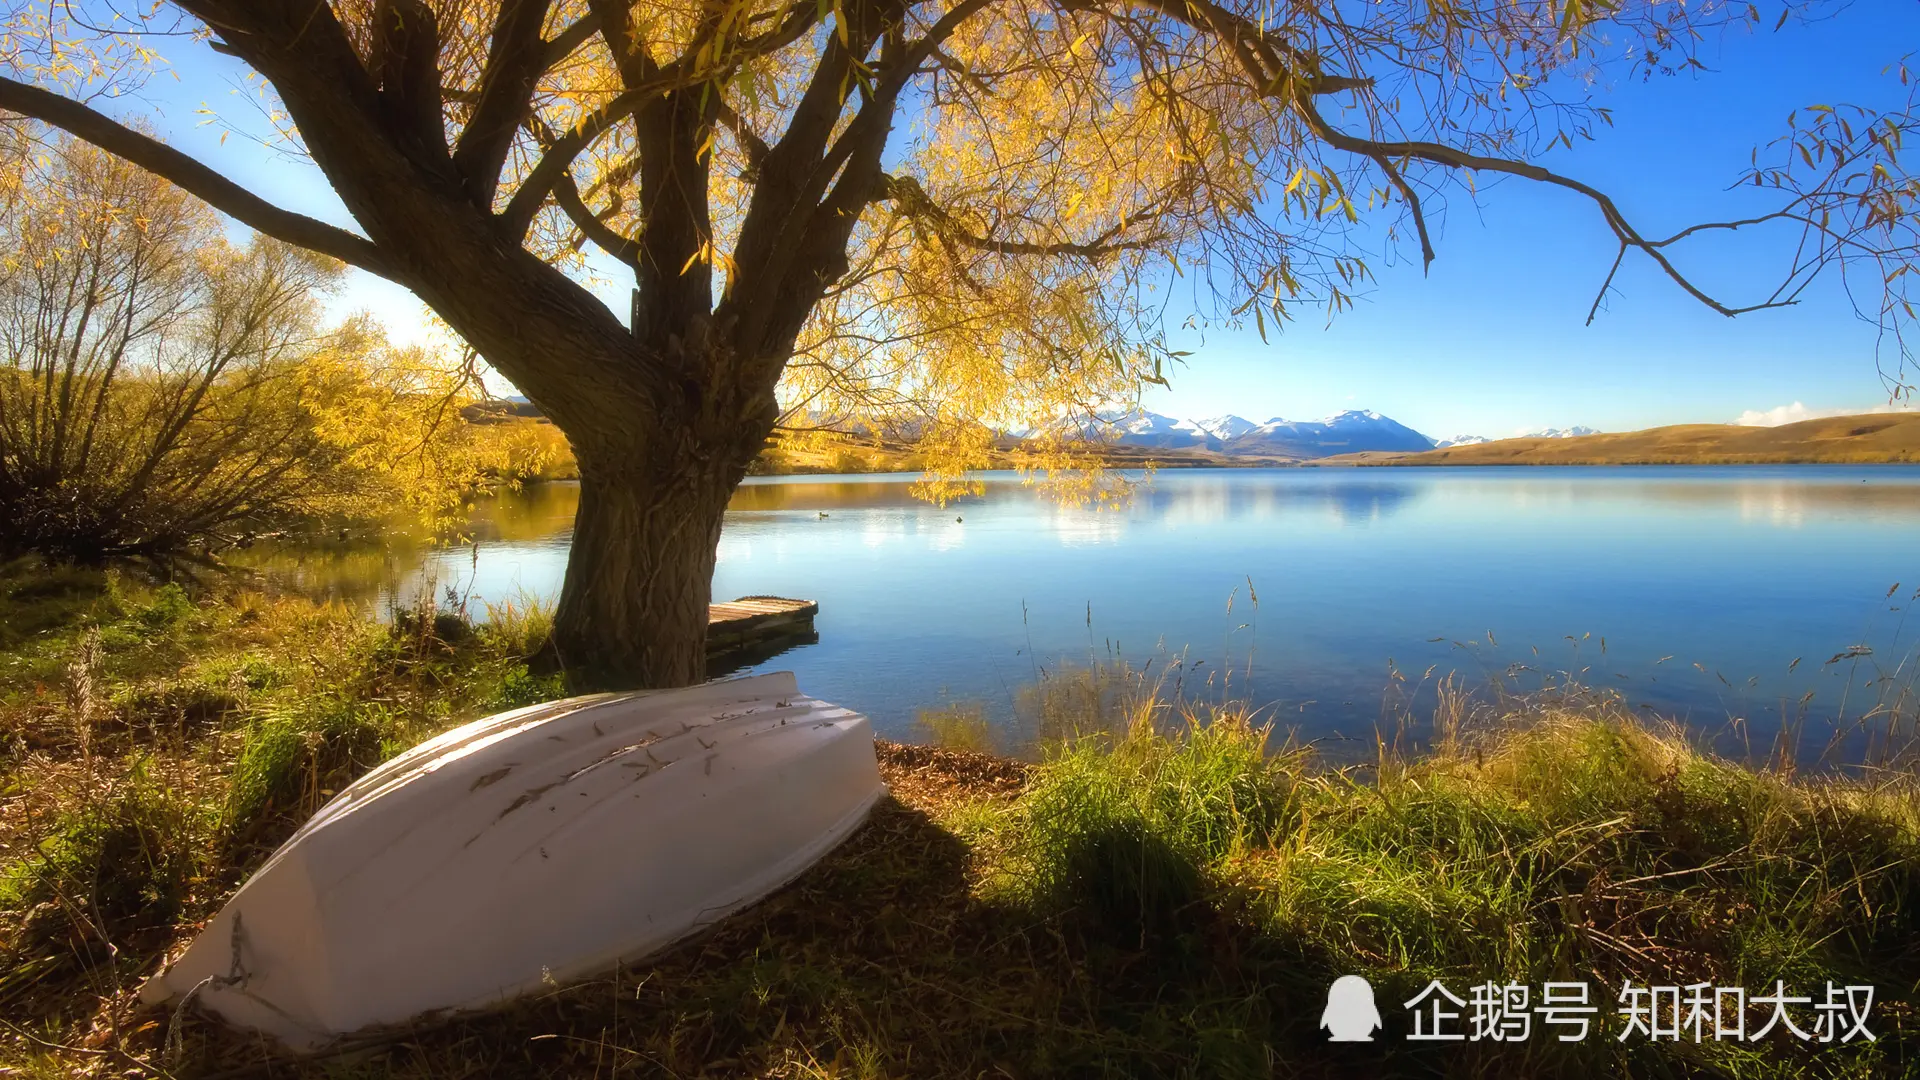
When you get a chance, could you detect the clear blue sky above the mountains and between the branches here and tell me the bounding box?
[108,0,1920,438]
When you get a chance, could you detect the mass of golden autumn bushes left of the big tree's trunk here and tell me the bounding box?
[0,130,555,559]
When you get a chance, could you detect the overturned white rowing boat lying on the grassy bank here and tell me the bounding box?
[142,673,885,1049]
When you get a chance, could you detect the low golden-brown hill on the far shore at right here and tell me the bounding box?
[1317,413,1920,465]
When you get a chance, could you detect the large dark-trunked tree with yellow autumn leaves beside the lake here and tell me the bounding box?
[0,0,1916,686]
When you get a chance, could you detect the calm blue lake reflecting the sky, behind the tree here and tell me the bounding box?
[247,465,1920,753]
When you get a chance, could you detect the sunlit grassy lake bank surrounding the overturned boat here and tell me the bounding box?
[0,573,1920,1078]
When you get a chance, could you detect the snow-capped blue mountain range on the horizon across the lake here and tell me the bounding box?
[1079,409,1597,459]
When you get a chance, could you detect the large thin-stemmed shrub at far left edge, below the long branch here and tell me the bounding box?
[0,138,359,559]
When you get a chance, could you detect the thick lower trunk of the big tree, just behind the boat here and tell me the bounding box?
[551,424,745,690]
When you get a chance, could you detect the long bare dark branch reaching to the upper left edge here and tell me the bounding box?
[0,77,409,284]
